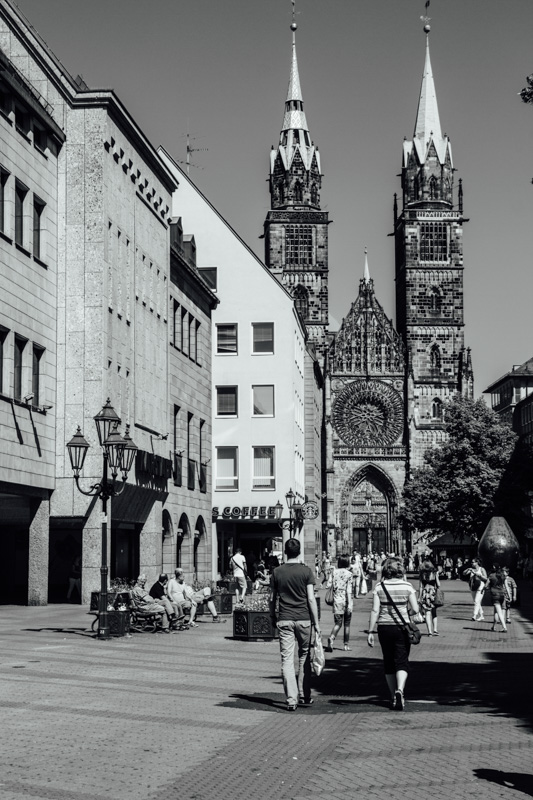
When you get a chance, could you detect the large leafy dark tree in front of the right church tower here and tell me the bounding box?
[402,396,517,539]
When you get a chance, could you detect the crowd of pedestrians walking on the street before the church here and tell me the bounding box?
[271,539,533,711]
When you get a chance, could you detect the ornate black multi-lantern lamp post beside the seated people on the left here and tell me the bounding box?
[67,398,137,639]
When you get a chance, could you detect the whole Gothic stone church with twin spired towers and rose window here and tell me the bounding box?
[264,18,473,553]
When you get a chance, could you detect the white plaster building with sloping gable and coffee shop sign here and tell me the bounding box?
[159,148,308,574]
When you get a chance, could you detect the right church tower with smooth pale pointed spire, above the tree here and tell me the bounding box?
[394,18,473,468]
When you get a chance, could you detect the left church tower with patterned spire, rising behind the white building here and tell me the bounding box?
[264,17,329,364]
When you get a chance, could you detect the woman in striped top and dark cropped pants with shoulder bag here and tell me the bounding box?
[367,558,419,711]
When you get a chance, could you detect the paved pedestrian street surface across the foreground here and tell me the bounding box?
[0,581,533,800]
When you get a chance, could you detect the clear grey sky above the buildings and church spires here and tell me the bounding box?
[12,0,533,396]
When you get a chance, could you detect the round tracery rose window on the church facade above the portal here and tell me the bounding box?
[331,381,403,447]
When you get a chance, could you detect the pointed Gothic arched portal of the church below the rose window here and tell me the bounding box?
[340,464,399,553]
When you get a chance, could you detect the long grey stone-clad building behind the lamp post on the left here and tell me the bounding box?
[0,0,217,604]
